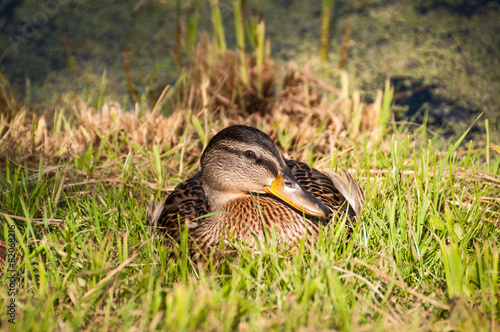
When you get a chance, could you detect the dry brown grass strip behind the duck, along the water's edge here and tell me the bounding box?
[0,43,381,171]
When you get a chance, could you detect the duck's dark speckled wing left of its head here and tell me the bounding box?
[148,171,209,241]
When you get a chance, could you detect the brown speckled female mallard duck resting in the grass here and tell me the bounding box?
[148,126,364,252]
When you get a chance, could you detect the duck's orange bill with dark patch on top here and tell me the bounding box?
[264,167,329,217]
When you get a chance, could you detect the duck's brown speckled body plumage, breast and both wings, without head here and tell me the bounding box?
[154,160,356,251]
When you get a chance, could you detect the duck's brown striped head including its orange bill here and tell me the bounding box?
[200,126,329,217]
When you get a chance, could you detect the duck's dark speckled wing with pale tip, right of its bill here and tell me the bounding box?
[285,159,364,221]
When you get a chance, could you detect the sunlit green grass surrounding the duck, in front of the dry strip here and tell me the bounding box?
[0,93,500,331]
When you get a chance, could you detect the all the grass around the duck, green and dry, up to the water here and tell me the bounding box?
[0,1,500,331]
